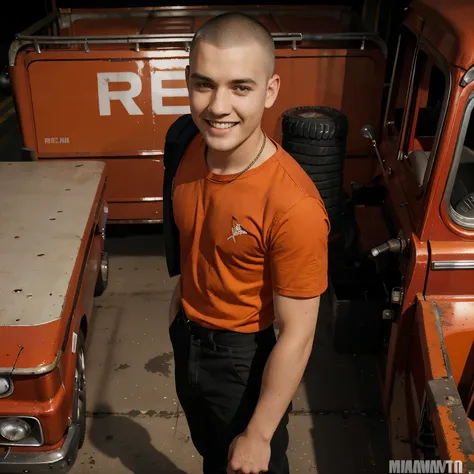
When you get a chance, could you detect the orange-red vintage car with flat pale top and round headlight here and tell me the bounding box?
[0,160,108,473]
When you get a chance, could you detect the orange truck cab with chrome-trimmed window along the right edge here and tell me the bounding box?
[361,0,474,464]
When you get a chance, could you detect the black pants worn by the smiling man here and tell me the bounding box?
[170,310,291,474]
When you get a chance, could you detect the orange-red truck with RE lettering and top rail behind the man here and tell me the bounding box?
[9,2,385,223]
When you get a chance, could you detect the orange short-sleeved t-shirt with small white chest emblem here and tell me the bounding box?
[173,133,330,333]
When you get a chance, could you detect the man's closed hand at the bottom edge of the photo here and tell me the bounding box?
[227,432,271,474]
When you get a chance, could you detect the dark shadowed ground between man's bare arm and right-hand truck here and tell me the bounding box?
[306,295,390,474]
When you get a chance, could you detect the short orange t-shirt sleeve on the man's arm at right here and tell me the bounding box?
[270,197,330,298]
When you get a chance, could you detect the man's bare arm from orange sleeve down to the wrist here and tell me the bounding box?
[246,294,320,442]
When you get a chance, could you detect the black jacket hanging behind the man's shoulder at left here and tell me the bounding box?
[163,114,198,277]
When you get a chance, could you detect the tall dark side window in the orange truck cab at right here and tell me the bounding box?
[381,27,450,236]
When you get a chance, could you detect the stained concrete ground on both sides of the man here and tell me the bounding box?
[71,226,389,474]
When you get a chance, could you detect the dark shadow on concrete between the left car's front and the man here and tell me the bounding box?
[88,404,186,474]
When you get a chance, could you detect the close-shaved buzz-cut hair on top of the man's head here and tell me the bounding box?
[189,12,275,78]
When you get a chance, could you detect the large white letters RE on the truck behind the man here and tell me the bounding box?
[97,61,190,115]
